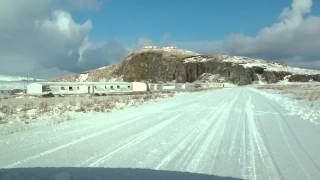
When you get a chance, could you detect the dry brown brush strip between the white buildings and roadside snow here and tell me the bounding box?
[0,92,173,124]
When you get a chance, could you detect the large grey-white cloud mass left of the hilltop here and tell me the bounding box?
[0,0,126,78]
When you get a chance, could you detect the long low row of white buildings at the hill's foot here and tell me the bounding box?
[27,82,232,96]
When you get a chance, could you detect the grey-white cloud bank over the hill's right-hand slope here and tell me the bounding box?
[180,0,320,69]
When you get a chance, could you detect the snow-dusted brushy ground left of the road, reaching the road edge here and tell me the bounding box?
[0,92,174,136]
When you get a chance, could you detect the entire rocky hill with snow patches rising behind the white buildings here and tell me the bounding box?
[55,49,320,85]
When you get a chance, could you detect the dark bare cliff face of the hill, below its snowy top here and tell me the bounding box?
[116,51,308,85]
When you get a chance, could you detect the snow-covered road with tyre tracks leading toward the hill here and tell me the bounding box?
[0,88,320,180]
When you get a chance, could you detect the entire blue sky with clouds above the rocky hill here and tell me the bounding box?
[0,0,320,79]
